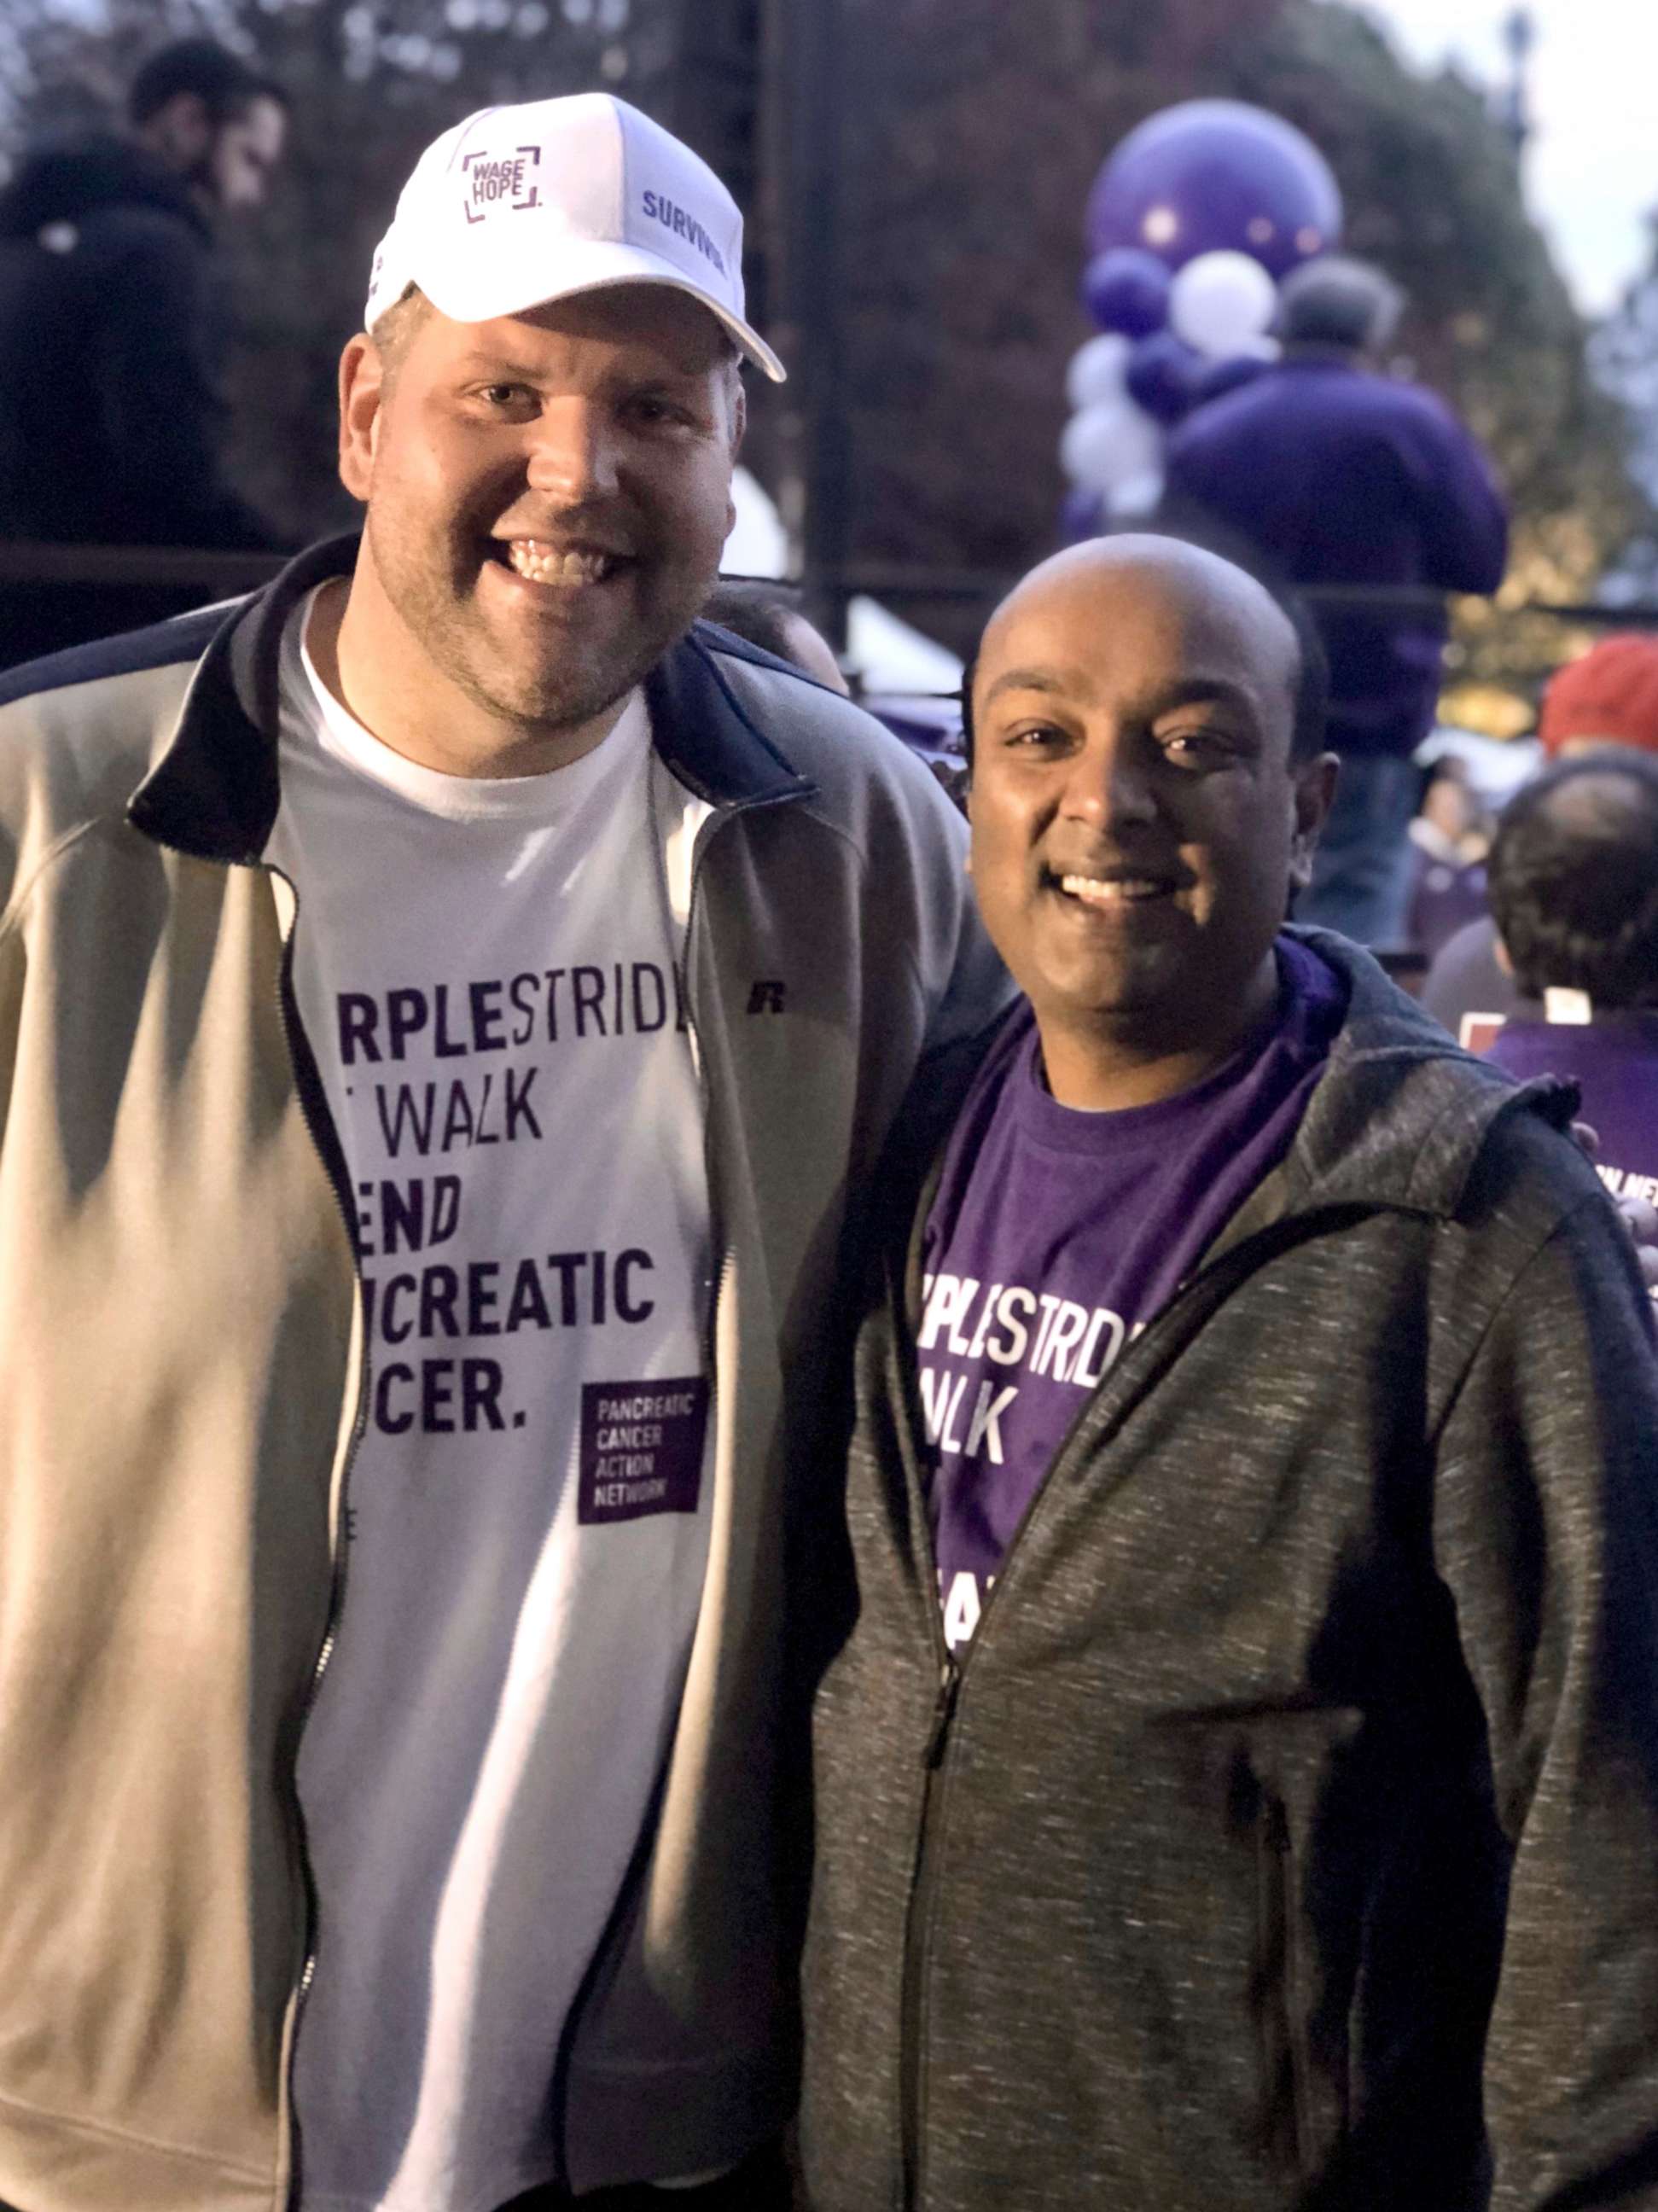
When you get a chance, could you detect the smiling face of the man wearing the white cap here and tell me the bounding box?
[338,285,742,774]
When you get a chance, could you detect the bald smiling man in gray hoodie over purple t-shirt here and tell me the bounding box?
[802,538,1658,2212]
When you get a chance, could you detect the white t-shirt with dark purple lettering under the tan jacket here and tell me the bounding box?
[265,602,712,2212]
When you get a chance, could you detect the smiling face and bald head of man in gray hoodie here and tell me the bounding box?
[969,538,1333,1103]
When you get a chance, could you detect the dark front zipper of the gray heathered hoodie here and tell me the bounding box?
[893,1212,1353,2212]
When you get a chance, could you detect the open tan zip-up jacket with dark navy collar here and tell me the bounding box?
[0,542,1006,2212]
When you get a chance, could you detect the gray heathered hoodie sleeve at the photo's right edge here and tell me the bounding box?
[1434,1196,1658,2212]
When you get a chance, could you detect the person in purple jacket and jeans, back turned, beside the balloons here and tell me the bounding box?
[1167,254,1508,946]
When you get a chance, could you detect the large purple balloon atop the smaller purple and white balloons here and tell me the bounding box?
[1088,100,1342,276]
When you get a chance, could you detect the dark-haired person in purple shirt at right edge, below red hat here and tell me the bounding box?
[1486,752,1658,1265]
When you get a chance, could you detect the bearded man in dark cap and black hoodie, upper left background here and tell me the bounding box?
[0,40,288,666]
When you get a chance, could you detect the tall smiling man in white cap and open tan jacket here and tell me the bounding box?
[0,95,1006,2212]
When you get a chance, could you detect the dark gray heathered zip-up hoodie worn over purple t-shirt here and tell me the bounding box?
[802,934,1658,2212]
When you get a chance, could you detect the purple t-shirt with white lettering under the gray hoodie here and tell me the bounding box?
[917,938,1347,1648]
